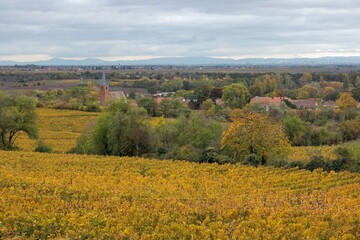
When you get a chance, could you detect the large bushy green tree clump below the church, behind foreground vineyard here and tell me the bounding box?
[75,101,153,156]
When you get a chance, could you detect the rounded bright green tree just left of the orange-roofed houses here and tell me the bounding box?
[222,83,249,108]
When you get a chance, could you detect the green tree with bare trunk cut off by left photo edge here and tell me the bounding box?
[0,92,38,150]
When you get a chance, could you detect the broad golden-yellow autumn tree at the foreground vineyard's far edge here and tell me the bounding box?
[221,110,290,165]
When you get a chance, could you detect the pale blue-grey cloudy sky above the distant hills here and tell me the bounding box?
[0,0,360,61]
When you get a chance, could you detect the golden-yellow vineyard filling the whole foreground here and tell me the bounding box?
[0,151,360,239]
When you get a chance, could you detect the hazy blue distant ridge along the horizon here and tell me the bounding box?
[0,56,360,66]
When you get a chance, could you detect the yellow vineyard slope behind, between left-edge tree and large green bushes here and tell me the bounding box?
[16,108,99,153]
